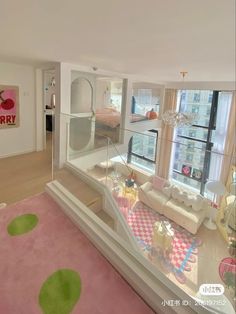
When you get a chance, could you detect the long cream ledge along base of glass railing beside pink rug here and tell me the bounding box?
[46,181,207,314]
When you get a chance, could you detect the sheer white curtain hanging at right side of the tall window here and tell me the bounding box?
[209,92,235,183]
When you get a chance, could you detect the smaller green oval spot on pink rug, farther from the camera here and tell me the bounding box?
[7,214,38,236]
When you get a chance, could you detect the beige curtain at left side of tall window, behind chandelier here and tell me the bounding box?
[157,89,178,179]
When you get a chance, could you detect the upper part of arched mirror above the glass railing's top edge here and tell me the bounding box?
[71,77,93,114]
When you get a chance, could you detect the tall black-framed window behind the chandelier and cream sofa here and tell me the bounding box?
[171,90,232,194]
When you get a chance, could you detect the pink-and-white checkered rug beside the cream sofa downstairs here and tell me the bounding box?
[127,202,201,283]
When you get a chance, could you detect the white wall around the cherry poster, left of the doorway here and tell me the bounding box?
[0,62,36,157]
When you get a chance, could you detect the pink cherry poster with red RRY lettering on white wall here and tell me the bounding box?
[0,85,19,129]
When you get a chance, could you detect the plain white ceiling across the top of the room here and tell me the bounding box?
[0,0,235,81]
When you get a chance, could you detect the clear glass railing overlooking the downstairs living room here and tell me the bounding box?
[54,115,236,313]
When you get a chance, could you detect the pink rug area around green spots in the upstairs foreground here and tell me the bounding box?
[0,193,154,314]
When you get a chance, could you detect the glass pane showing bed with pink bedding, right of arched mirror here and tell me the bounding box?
[95,77,123,148]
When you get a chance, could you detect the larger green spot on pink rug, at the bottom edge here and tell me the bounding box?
[39,269,81,314]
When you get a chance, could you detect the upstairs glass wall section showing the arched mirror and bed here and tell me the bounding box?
[68,71,124,154]
